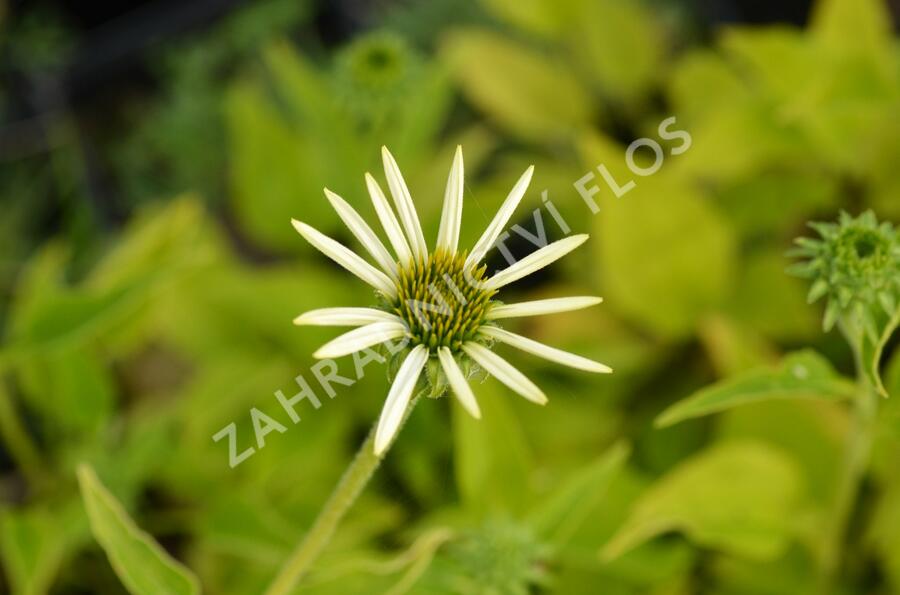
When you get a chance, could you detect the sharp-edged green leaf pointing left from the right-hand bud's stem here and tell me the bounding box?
[656,350,857,427]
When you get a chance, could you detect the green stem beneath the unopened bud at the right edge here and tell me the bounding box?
[815,333,879,595]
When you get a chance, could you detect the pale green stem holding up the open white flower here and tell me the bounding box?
[265,394,420,595]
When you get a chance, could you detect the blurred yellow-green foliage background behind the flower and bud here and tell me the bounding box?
[0,0,900,595]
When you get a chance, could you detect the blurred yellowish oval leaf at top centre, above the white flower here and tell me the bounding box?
[441,29,592,140]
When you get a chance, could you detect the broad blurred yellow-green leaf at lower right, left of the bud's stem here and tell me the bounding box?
[603,442,801,559]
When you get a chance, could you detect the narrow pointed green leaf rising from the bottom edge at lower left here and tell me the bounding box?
[78,465,200,595]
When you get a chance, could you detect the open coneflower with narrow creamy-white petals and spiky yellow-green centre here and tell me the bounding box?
[293,147,612,455]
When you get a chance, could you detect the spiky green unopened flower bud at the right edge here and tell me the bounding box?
[790,211,900,340]
